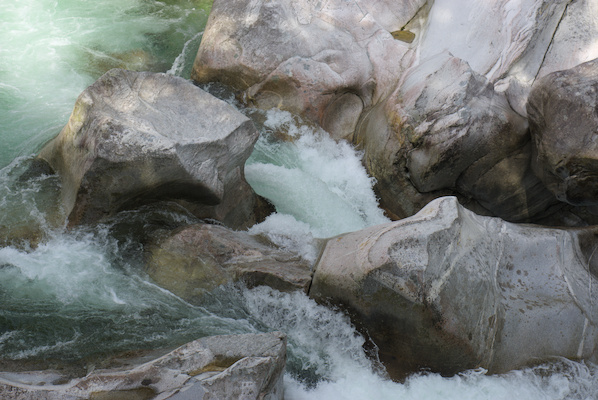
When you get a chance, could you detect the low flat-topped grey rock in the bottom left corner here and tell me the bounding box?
[0,332,286,400]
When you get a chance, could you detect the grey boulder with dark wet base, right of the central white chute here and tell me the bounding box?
[357,52,557,221]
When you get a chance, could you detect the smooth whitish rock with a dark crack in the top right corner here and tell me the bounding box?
[419,0,598,116]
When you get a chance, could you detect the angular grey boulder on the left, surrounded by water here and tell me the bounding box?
[39,69,258,228]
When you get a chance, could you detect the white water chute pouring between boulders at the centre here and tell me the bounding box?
[245,109,389,260]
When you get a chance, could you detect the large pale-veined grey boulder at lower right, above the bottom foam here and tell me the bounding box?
[310,197,598,376]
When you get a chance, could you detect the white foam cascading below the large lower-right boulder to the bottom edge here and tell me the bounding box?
[243,287,598,400]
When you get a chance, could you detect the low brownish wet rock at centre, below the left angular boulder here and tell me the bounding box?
[146,224,311,302]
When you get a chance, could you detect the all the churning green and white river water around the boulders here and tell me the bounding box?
[0,0,598,400]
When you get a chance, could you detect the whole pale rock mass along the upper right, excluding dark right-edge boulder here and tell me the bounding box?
[192,0,598,224]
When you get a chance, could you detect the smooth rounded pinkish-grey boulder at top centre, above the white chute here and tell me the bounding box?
[191,0,426,140]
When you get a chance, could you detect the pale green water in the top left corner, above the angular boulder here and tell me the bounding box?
[0,0,211,167]
